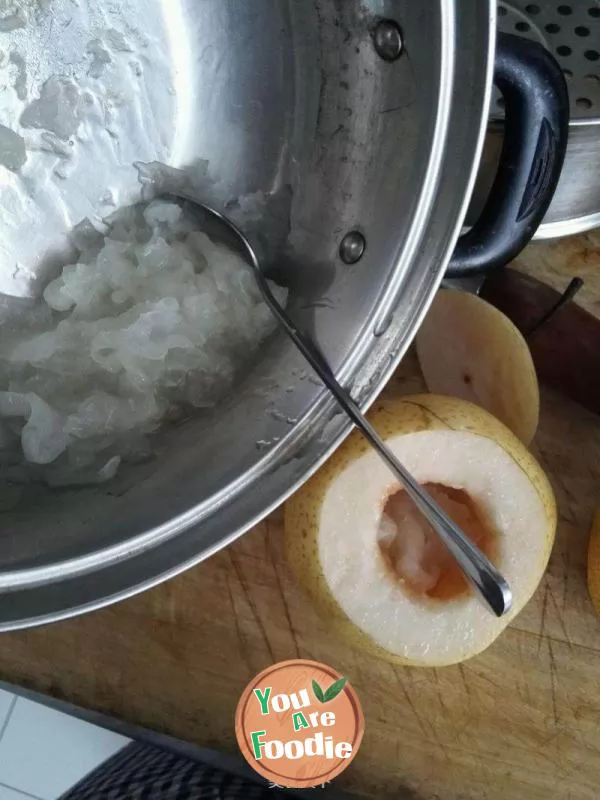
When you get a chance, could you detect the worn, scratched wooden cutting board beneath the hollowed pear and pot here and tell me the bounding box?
[0,236,600,800]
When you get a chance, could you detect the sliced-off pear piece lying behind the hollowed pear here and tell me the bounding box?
[417,289,540,446]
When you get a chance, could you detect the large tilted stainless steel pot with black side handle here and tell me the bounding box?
[0,0,566,629]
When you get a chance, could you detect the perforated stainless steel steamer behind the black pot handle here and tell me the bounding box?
[468,0,600,239]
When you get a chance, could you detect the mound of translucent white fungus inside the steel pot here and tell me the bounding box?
[0,201,287,486]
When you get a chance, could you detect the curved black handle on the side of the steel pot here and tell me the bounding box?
[446,33,569,278]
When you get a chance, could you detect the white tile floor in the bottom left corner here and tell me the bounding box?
[0,689,129,800]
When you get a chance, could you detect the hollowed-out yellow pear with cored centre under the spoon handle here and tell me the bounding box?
[285,395,556,666]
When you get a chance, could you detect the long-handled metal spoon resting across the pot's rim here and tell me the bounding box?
[178,196,512,617]
